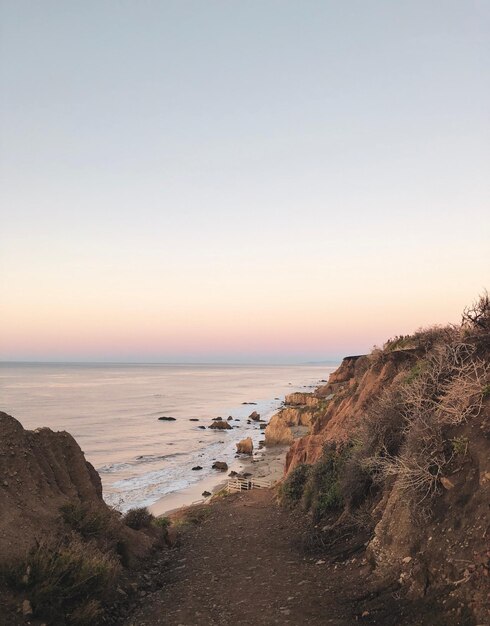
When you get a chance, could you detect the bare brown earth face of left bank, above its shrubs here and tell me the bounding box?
[0,412,152,563]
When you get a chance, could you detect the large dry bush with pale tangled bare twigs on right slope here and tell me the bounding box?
[363,327,490,504]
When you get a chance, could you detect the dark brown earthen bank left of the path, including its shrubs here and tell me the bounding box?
[0,412,165,626]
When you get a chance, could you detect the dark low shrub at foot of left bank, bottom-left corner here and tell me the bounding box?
[6,539,120,625]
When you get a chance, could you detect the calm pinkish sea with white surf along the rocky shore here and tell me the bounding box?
[0,363,334,510]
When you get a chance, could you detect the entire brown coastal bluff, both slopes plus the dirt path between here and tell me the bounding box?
[0,297,490,626]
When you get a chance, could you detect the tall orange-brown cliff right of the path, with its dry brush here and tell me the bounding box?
[278,297,490,624]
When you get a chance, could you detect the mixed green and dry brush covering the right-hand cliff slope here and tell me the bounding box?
[281,294,490,523]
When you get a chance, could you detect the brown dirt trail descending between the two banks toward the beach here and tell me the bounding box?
[126,490,456,626]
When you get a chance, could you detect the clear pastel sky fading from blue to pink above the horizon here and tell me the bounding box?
[0,0,490,362]
